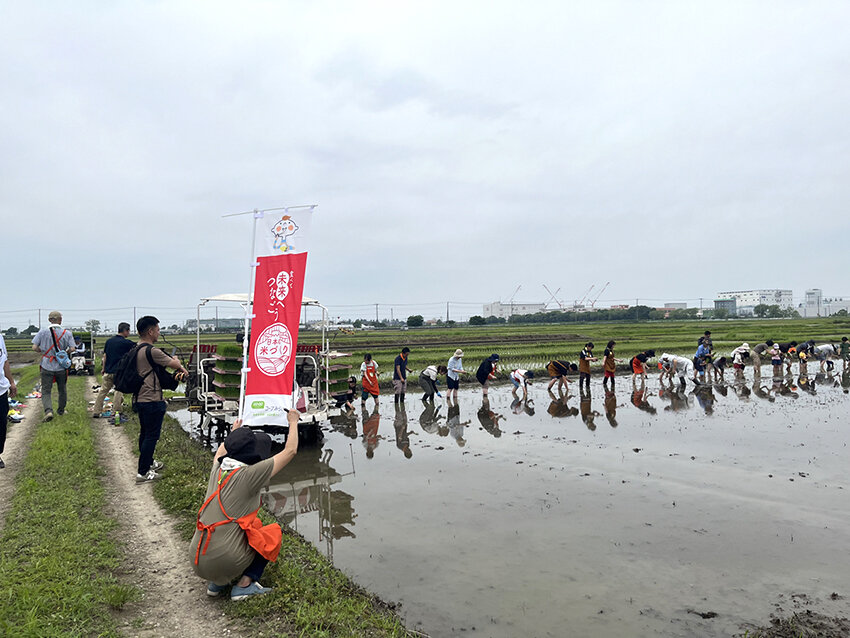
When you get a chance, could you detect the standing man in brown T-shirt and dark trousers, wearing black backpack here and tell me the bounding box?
[128,315,188,483]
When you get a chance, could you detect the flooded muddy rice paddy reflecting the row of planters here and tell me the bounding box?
[174,374,850,637]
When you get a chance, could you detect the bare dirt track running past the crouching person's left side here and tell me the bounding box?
[86,383,238,638]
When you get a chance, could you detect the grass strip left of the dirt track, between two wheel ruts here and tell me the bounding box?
[0,378,138,636]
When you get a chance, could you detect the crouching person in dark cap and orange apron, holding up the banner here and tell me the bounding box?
[189,410,299,600]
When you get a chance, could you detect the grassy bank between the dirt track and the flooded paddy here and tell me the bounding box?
[126,417,410,638]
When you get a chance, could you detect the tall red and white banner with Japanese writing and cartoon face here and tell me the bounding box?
[242,207,313,425]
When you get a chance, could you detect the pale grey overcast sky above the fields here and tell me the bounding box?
[0,0,850,327]
